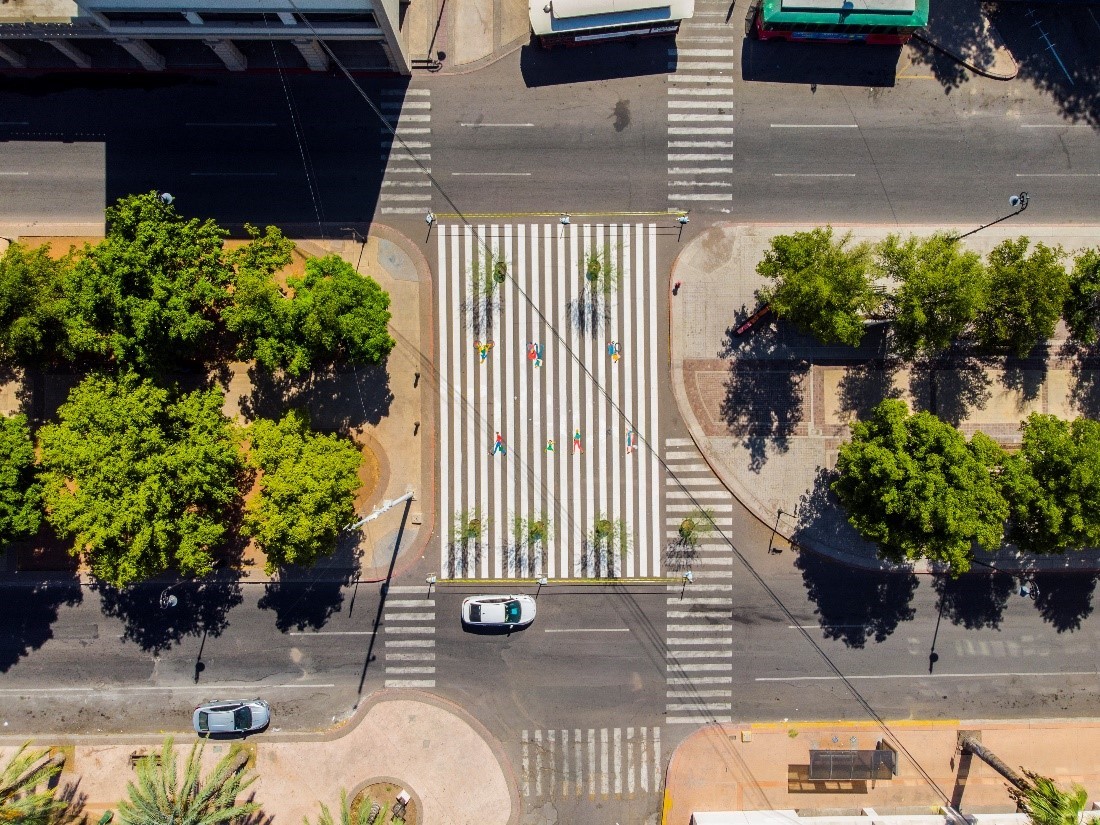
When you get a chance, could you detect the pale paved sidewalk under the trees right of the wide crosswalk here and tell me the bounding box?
[670,222,1100,571]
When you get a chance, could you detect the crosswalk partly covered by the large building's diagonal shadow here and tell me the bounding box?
[378,89,431,215]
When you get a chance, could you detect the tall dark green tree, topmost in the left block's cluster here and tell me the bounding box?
[65,193,231,369]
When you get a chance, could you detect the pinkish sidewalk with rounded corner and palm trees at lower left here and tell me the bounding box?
[0,691,521,825]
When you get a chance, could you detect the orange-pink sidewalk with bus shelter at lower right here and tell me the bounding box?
[662,719,1100,825]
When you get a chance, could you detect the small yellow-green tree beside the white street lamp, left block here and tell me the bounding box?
[244,410,362,573]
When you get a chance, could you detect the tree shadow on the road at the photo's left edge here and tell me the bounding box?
[0,573,84,673]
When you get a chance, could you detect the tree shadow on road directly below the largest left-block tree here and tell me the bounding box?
[92,572,243,653]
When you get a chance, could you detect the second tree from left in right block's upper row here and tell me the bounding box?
[878,234,986,355]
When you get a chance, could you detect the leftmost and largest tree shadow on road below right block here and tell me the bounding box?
[794,550,917,648]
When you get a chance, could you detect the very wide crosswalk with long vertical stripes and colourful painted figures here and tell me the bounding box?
[437,223,662,579]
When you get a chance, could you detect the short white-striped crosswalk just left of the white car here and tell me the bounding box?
[382,584,436,688]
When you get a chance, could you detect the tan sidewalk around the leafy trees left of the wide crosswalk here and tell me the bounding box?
[0,222,437,584]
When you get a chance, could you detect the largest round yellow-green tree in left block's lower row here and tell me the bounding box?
[40,373,240,587]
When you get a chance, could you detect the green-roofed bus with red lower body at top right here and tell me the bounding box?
[746,0,928,44]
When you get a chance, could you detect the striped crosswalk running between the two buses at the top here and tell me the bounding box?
[668,0,735,211]
